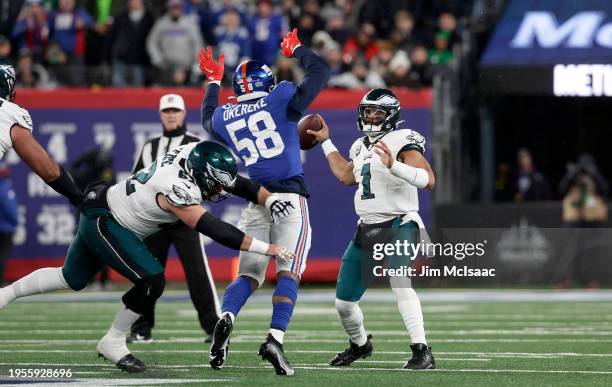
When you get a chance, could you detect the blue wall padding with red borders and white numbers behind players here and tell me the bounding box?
[5,88,431,281]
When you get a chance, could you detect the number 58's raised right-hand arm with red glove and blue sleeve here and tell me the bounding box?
[281,28,330,121]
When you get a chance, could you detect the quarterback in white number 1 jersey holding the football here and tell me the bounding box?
[309,89,436,370]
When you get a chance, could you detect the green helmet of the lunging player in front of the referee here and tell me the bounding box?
[187,141,238,201]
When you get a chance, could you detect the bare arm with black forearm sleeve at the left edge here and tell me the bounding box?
[11,125,83,206]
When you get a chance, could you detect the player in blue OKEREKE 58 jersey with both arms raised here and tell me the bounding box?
[200,29,329,375]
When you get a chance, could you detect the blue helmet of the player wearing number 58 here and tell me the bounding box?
[232,60,276,102]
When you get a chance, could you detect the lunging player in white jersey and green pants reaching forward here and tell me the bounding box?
[0,141,293,372]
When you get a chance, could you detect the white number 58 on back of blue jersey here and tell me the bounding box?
[226,110,285,167]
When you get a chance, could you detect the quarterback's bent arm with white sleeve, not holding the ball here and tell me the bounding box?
[374,140,436,190]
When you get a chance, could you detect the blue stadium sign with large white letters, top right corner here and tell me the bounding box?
[481,0,612,97]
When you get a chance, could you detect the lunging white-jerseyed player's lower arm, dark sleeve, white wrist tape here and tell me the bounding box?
[157,194,293,260]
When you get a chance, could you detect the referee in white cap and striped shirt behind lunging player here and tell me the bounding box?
[127,94,220,343]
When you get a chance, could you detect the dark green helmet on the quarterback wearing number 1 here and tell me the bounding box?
[357,89,400,138]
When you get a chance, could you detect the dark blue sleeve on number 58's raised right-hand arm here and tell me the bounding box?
[287,46,330,121]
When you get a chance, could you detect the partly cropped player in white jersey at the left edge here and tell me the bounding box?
[0,58,83,205]
